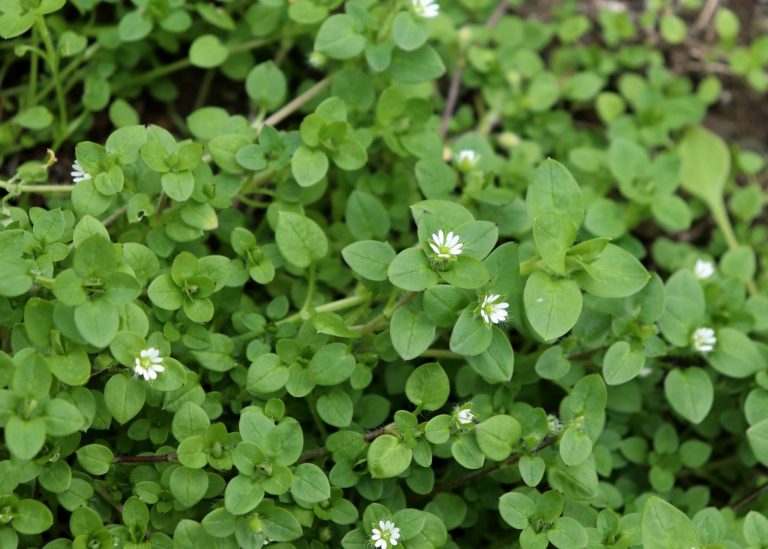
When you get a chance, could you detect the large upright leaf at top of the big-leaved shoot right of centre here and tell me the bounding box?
[525,159,584,228]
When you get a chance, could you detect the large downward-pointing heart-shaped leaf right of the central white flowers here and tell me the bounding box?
[523,271,582,341]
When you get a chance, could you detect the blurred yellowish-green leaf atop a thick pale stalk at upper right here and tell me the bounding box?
[680,126,731,205]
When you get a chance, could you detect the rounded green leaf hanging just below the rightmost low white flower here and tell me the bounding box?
[664,367,715,423]
